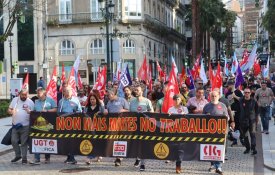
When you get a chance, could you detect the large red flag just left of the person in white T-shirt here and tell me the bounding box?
[161,70,180,113]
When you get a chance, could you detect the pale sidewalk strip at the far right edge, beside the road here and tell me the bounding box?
[262,118,275,171]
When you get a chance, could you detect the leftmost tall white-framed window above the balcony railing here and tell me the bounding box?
[59,0,72,21]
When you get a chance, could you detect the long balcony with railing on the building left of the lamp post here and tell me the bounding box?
[47,12,104,25]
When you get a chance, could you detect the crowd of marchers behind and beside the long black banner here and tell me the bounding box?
[5,71,275,174]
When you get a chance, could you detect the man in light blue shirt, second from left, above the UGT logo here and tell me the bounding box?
[30,87,57,165]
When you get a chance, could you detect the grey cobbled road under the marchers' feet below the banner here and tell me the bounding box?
[0,147,256,175]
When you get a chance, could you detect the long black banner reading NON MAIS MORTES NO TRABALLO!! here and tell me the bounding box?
[29,112,227,161]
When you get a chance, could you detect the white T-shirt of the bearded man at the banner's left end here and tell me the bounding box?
[9,97,34,126]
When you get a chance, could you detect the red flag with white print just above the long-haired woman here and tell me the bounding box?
[93,66,107,99]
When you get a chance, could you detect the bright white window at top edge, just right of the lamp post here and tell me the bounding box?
[124,0,141,19]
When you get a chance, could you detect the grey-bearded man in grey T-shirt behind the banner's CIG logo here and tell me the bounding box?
[203,91,229,174]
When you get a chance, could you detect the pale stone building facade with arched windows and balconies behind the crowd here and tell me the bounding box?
[40,0,186,84]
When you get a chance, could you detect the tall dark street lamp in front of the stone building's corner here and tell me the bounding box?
[98,0,115,81]
